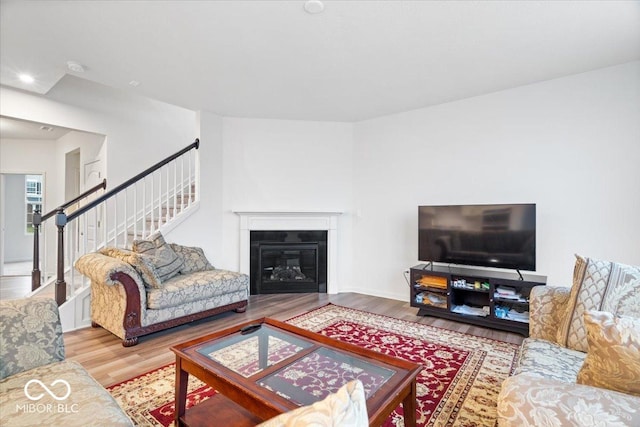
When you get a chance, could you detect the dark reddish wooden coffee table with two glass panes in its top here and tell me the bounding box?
[171,318,422,427]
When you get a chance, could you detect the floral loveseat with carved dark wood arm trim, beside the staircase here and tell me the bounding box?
[75,233,249,347]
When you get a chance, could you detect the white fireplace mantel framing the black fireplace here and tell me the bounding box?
[234,211,342,294]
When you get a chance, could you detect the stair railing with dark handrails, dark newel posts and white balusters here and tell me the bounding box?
[31,139,200,305]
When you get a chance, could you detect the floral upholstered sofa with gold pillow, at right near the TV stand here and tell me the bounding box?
[498,256,640,427]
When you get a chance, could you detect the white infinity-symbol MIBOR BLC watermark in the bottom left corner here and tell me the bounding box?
[16,379,78,414]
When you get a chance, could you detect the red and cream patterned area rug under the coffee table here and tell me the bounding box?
[108,304,518,427]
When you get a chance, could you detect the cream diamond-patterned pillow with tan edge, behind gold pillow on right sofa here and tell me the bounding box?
[557,255,640,352]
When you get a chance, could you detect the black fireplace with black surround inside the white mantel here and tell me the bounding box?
[250,230,327,295]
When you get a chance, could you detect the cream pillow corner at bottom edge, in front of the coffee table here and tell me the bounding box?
[257,380,369,427]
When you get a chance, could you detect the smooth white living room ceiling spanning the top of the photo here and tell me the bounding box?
[0,0,640,121]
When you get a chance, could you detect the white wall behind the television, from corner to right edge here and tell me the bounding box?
[354,62,640,299]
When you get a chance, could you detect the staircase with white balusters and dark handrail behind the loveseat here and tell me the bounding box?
[32,139,200,331]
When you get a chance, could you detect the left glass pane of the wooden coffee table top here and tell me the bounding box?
[198,324,313,378]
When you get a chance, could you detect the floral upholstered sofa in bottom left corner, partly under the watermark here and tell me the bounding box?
[0,298,133,427]
